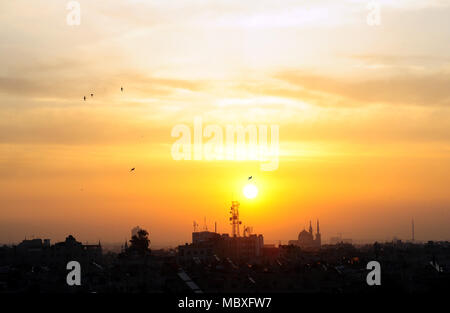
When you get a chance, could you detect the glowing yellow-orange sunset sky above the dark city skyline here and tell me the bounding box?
[0,0,450,247]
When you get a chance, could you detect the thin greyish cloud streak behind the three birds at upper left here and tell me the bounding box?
[0,69,207,101]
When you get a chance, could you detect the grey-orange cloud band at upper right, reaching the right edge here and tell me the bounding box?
[271,71,450,106]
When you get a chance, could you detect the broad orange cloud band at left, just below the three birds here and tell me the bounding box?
[0,107,170,145]
